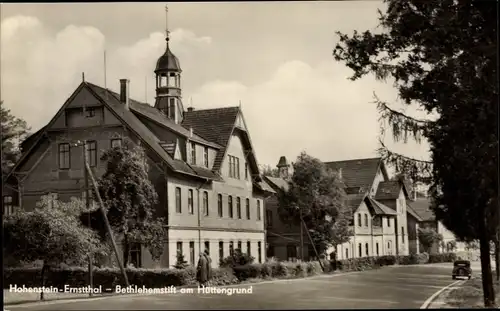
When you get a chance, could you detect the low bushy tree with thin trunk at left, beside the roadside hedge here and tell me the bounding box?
[3,196,105,300]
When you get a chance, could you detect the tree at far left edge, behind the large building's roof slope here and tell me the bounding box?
[0,101,30,175]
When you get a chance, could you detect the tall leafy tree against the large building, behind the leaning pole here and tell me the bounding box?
[97,140,166,266]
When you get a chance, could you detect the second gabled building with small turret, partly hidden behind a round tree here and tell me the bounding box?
[265,157,418,260]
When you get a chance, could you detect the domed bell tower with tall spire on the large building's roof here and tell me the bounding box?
[155,6,184,124]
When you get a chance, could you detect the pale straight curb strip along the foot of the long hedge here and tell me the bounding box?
[4,271,364,308]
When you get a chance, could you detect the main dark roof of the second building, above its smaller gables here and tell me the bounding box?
[325,158,387,191]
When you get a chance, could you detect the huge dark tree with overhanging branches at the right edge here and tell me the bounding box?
[334,0,500,307]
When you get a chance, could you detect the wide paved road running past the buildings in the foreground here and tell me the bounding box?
[8,264,478,311]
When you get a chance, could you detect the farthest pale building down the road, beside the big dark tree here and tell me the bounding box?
[410,197,465,253]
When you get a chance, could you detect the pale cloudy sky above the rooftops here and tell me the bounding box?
[0,0,429,171]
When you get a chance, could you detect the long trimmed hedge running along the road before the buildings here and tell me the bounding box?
[4,253,457,290]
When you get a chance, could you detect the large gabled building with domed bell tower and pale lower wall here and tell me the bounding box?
[3,8,273,267]
